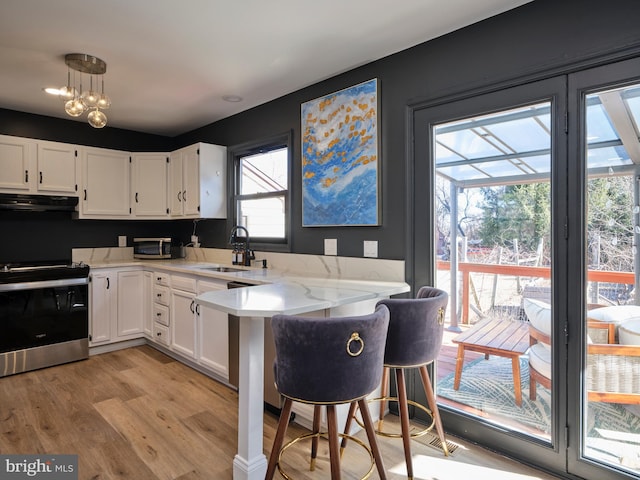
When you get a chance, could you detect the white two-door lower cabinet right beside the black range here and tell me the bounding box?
[90,269,143,346]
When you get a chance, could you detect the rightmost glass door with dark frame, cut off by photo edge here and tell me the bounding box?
[569,55,640,478]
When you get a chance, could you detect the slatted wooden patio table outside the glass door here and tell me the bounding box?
[452,318,529,406]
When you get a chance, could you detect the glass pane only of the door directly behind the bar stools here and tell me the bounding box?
[431,99,554,441]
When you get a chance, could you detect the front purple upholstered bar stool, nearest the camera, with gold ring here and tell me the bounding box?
[265,305,389,480]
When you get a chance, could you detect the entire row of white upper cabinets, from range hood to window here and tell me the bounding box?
[0,135,227,220]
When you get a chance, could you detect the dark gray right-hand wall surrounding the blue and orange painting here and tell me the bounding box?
[177,0,640,259]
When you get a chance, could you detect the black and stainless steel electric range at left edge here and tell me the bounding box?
[0,261,89,377]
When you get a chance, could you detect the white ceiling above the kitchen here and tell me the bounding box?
[0,0,530,136]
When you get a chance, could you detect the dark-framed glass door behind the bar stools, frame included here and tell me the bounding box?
[412,78,567,469]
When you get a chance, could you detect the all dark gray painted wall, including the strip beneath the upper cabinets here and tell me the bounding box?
[0,0,640,259]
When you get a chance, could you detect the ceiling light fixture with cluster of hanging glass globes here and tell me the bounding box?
[57,53,111,128]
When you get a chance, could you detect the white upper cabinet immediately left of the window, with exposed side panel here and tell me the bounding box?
[168,143,227,218]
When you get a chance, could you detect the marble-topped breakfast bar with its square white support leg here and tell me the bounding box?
[196,277,410,480]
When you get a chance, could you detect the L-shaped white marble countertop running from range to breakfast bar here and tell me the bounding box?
[90,260,410,317]
